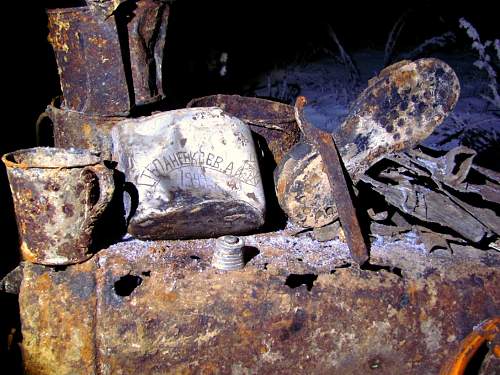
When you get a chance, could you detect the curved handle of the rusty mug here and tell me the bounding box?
[82,164,115,231]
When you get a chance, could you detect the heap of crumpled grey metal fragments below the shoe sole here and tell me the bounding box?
[361,147,500,243]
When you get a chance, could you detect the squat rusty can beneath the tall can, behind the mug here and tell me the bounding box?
[45,105,124,160]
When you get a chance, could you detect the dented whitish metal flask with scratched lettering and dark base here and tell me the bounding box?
[111,107,265,239]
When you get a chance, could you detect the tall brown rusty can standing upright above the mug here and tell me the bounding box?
[47,7,131,115]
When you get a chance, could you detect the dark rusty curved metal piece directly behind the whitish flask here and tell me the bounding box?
[187,94,300,164]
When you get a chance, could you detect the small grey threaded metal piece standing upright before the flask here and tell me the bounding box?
[212,236,245,271]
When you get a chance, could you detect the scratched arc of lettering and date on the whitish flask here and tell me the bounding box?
[137,150,260,187]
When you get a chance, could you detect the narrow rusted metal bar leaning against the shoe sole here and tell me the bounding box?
[295,96,369,265]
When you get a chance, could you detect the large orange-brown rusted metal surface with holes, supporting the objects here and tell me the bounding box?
[20,232,500,374]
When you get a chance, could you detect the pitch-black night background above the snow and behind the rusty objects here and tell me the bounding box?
[0,0,500,366]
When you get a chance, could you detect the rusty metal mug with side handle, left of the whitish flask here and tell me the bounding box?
[2,147,114,265]
